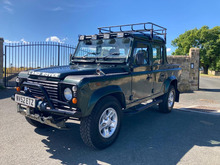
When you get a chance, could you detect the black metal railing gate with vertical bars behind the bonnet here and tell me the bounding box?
[3,42,75,87]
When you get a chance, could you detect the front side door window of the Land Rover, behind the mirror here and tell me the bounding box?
[133,43,149,65]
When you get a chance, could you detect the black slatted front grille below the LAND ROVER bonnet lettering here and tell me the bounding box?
[27,79,59,100]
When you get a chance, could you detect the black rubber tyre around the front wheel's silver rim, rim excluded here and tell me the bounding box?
[80,96,122,149]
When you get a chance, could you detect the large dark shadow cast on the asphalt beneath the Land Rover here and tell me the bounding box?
[35,108,220,165]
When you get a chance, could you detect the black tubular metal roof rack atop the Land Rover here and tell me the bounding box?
[98,22,167,42]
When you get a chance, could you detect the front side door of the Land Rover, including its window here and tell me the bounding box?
[131,42,153,101]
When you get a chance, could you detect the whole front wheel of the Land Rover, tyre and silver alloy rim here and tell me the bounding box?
[80,96,121,149]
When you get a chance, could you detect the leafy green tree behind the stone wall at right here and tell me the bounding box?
[172,26,220,74]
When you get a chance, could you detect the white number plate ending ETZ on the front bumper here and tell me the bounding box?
[15,94,36,108]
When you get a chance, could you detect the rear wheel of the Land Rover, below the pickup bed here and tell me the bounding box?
[159,85,176,113]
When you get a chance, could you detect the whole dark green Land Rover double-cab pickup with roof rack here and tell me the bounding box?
[12,22,181,149]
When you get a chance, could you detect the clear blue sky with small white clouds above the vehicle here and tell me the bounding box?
[0,0,220,54]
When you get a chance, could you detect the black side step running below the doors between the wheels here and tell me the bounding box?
[123,100,163,115]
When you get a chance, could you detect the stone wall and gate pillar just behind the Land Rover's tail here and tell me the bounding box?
[167,48,199,92]
